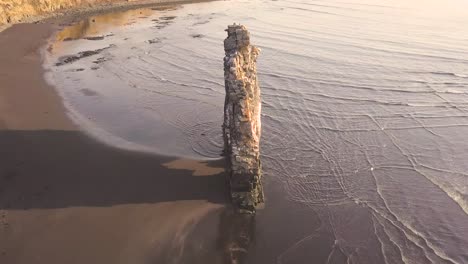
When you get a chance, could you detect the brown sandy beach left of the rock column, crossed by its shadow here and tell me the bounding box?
[0,13,229,264]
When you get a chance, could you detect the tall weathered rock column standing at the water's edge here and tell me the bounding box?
[223,24,264,213]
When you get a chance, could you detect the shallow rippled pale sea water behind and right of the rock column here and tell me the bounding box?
[46,0,468,263]
